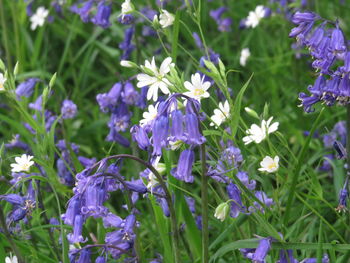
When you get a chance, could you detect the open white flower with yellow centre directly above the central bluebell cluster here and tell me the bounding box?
[184,73,211,101]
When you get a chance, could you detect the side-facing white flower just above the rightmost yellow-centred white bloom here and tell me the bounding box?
[243,117,279,144]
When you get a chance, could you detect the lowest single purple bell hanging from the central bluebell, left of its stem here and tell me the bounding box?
[172,149,194,183]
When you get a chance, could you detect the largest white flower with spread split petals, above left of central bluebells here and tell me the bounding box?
[137,57,175,101]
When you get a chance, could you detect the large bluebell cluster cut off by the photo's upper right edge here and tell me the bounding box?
[289,12,350,112]
